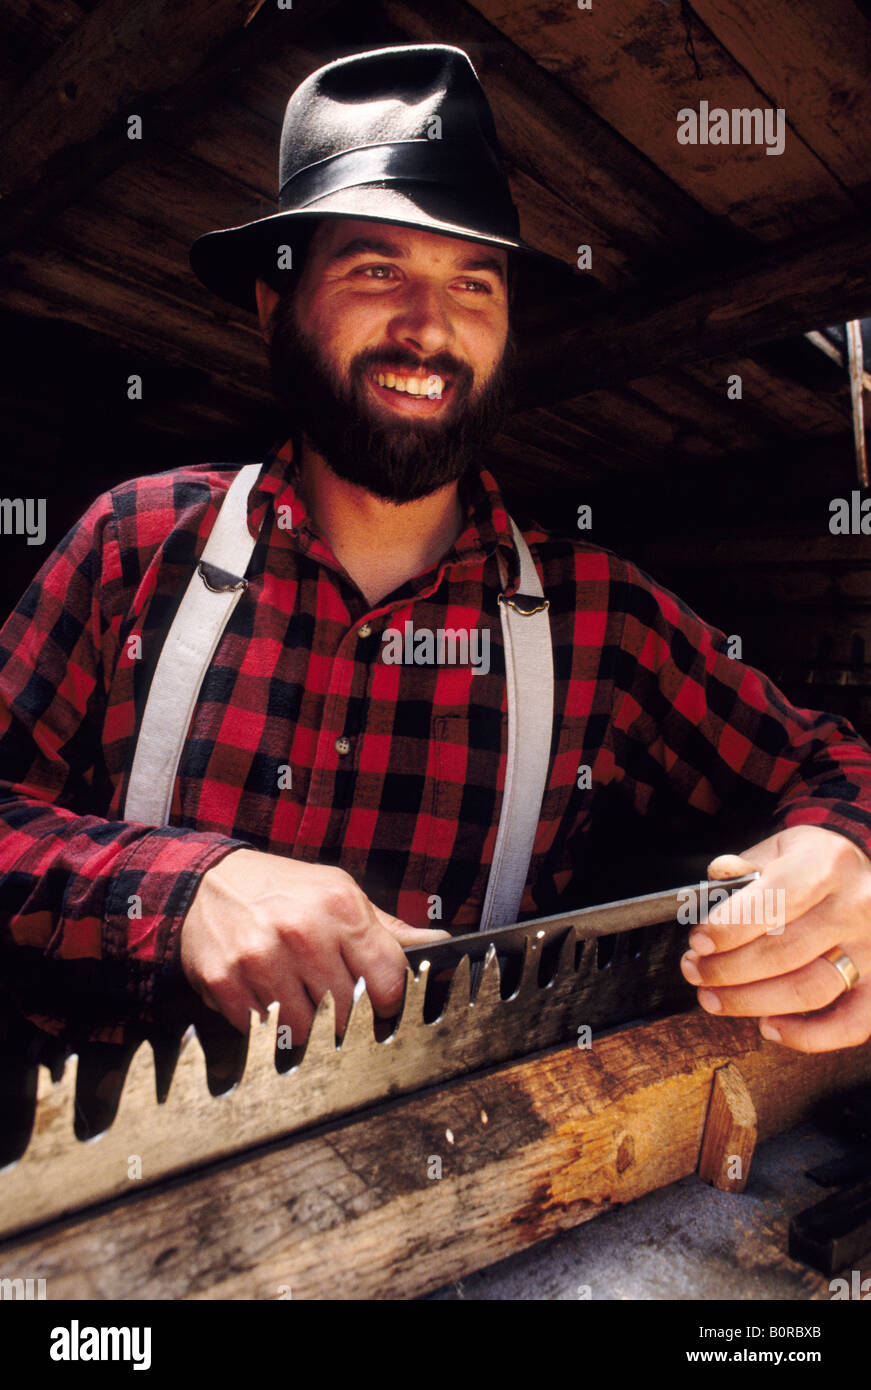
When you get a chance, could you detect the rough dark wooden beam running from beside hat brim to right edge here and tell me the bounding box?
[518,218,871,404]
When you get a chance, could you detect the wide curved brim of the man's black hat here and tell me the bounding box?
[190,183,602,357]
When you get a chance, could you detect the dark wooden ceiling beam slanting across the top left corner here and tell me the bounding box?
[0,0,336,250]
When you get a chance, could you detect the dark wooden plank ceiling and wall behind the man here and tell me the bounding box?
[0,0,871,735]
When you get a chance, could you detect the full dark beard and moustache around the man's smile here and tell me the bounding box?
[269,295,514,503]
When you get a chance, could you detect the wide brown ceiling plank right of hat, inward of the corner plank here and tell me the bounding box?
[469,0,868,240]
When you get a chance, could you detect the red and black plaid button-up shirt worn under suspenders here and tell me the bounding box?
[0,445,871,1040]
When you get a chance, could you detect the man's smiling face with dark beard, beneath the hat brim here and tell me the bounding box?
[260,218,508,502]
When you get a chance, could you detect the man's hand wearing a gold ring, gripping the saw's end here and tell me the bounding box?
[681,826,871,1052]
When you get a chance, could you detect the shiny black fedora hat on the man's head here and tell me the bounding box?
[190,43,597,375]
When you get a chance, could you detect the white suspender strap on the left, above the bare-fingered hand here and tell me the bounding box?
[122,463,261,826]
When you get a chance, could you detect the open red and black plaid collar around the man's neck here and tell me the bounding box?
[249,439,520,596]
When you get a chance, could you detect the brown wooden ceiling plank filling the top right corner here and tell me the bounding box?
[693,0,871,198]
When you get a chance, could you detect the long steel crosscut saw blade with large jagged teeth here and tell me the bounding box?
[0,873,758,1234]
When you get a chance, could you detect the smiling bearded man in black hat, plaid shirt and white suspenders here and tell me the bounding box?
[0,44,871,1051]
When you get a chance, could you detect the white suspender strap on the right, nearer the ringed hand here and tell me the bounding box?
[479,517,553,931]
